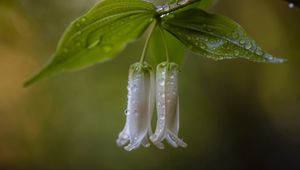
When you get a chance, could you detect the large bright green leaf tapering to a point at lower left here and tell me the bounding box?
[24,0,155,86]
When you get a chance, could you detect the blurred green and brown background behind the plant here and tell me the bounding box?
[0,0,300,169]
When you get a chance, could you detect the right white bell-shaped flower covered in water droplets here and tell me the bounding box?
[150,62,187,149]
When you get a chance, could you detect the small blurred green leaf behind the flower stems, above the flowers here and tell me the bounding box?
[149,27,186,65]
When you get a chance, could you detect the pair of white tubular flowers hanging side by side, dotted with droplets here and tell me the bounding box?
[117,62,187,151]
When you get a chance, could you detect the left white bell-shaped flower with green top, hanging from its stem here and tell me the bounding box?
[116,63,155,151]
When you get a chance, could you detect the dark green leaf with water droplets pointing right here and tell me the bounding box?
[162,9,285,63]
